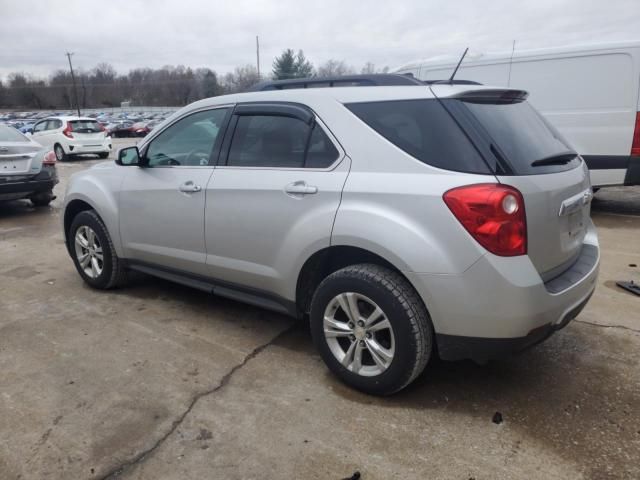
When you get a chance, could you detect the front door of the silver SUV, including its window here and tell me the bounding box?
[119,108,229,274]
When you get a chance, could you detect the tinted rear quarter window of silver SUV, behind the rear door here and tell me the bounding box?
[346,99,491,174]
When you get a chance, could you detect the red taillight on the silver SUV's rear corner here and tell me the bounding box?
[443,183,527,257]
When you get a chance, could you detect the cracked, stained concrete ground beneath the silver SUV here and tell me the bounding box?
[0,137,640,480]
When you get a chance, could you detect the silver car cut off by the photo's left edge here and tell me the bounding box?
[0,124,58,207]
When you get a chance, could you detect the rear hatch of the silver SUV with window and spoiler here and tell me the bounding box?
[433,88,592,281]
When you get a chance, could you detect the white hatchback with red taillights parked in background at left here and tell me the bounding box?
[32,116,111,162]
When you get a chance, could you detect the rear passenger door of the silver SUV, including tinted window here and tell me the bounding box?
[205,104,349,299]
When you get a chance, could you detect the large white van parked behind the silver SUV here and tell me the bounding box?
[395,42,640,187]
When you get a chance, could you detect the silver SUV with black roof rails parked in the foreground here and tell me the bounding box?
[64,76,600,394]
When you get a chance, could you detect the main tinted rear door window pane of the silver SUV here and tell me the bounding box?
[227,115,309,168]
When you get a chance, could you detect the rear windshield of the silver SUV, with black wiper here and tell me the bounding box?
[462,101,580,175]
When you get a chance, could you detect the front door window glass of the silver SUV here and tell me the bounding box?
[146,108,227,167]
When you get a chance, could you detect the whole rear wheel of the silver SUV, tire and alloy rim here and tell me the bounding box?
[310,264,434,395]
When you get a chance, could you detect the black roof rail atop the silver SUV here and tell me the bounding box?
[247,73,424,92]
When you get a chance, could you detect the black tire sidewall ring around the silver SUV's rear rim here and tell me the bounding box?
[310,275,418,395]
